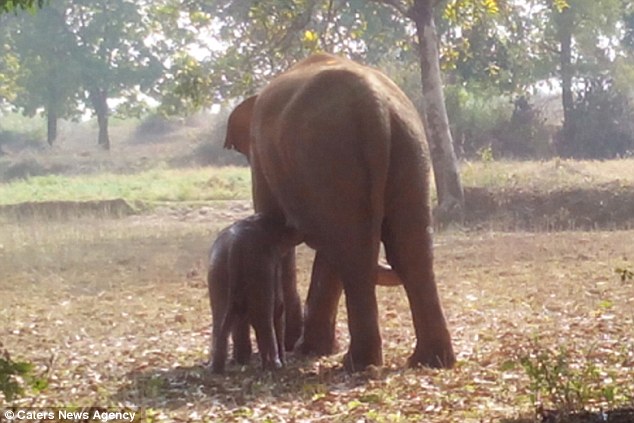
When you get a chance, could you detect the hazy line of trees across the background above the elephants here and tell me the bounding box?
[0,0,634,161]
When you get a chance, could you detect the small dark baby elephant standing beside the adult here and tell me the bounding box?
[207,214,301,373]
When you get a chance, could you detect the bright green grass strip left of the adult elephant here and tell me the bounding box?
[0,167,251,204]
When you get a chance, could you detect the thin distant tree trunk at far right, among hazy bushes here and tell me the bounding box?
[555,7,575,155]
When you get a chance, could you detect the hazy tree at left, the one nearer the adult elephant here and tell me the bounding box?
[68,0,163,150]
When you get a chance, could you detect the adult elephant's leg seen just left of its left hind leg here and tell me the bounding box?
[296,251,343,355]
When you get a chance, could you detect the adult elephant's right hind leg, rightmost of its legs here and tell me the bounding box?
[383,214,455,368]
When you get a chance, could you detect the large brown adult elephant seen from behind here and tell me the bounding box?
[225,54,455,371]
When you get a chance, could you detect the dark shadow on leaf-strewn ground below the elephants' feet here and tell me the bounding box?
[113,354,356,410]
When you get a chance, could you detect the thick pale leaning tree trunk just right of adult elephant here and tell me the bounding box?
[409,0,464,223]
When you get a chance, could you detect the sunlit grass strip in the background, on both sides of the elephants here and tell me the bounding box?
[0,158,634,204]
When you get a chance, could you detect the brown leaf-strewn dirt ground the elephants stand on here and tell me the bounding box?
[0,202,634,422]
